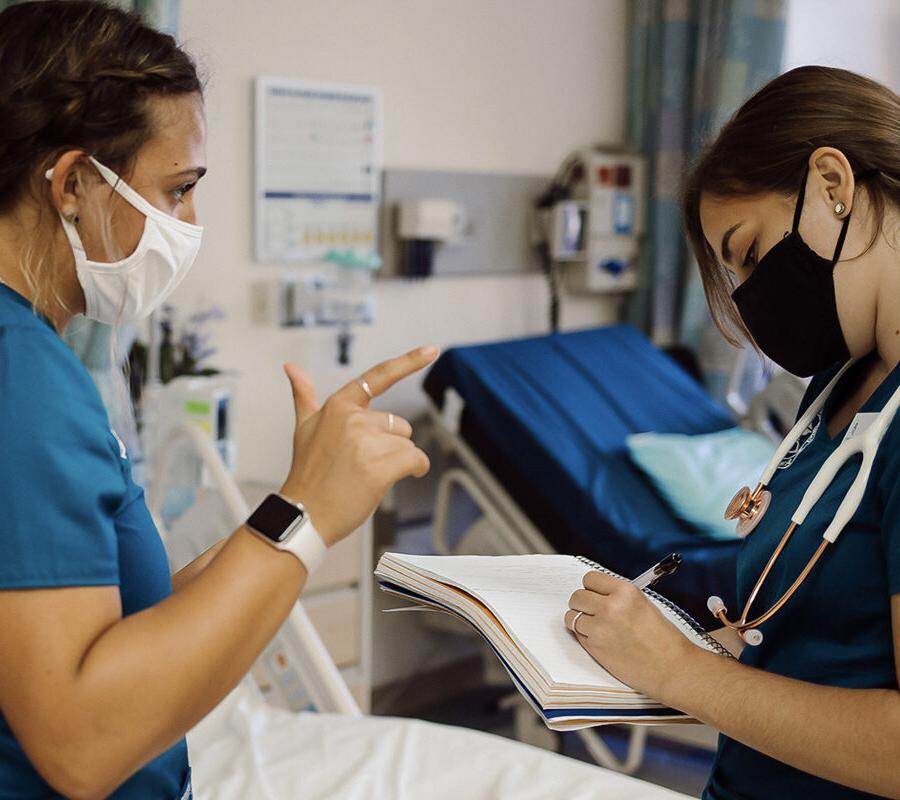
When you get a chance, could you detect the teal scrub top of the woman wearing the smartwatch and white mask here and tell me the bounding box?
[0,284,190,800]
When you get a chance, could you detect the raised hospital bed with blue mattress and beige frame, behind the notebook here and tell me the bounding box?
[424,325,780,773]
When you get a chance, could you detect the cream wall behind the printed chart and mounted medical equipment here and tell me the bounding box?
[173,0,626,481]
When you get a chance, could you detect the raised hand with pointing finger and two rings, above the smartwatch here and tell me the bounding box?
[282,347,438,546]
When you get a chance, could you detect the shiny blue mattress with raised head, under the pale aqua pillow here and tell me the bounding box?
[425,325,738,622]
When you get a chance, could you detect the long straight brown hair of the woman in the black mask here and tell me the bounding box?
[682,66,900,345]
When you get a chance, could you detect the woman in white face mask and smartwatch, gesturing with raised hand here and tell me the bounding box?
[0,0,436,800]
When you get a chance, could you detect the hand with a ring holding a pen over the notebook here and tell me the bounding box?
[565,572,699,700]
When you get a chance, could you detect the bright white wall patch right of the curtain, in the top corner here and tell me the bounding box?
[784,0,900,86]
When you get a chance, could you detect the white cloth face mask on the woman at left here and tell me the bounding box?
[47,156,203,325]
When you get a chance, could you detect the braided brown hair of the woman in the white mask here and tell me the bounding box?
[0,0,203,309]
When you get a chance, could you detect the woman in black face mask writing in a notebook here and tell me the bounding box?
[566,67,900,800]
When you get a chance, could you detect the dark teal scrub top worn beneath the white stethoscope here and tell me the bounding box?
[703,366,900,800]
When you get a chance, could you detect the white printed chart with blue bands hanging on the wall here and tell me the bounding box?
[256,77,382,263]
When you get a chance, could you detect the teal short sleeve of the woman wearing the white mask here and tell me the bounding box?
[0,327,126,589]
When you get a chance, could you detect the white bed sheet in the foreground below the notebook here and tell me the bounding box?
[188,686,687,800]
